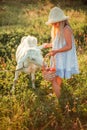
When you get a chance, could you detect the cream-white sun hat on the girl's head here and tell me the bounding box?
[46,7,69,24]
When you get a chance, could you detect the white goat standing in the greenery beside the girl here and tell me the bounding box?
[12,36,44,90]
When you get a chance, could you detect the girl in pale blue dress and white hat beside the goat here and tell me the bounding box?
[43,7,79,97]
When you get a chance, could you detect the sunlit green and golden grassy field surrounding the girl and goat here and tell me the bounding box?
[0,0,87,130]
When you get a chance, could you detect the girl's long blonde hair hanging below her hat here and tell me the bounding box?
[51,20,71,42]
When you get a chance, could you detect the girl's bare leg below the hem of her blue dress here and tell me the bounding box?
[52,76,62,98]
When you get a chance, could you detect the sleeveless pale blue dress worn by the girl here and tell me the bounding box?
[51,26,79,79]
